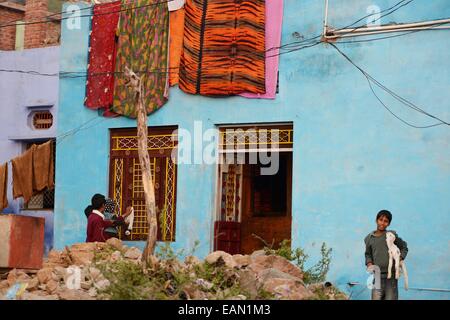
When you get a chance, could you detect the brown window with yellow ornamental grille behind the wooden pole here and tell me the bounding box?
[109,127,177,241]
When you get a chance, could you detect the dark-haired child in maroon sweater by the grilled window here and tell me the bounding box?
[85,193,131,242]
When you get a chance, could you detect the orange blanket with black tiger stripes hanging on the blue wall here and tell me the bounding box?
[179,0,266,95]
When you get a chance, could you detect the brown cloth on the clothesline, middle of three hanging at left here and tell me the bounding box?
[12,144,36,203]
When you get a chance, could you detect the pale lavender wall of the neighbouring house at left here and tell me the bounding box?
[0,46,60,254]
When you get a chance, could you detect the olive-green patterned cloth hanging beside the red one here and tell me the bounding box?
[111,0,169,118]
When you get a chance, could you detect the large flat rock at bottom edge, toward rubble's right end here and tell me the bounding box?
[263,278,314,300]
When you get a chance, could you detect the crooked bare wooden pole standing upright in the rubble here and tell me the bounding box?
[125,67,158,268]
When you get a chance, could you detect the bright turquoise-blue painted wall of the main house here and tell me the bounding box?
[55,0,450,299]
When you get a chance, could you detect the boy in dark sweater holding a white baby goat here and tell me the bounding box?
[364,210,408,300]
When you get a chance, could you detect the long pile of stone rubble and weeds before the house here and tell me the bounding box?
[0,238,347,300]
